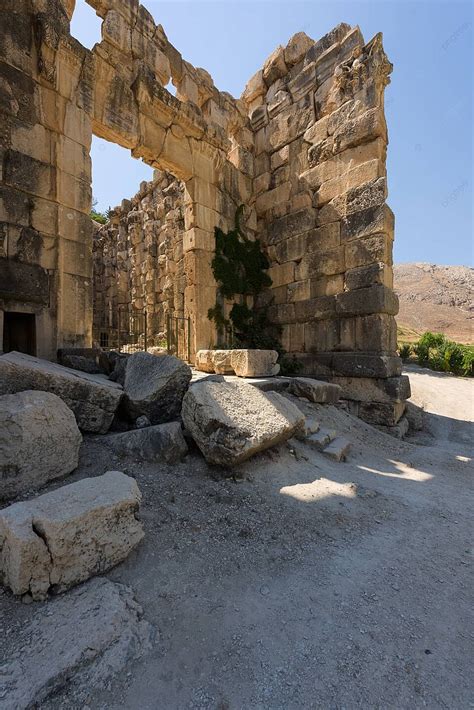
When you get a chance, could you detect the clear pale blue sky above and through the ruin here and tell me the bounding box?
[72,0,474,265]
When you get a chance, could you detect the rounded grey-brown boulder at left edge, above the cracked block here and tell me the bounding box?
[0,390,82,500]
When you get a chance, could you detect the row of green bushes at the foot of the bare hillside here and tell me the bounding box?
[398,331,474,377]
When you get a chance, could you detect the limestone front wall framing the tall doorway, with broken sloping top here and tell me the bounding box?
[0,0,253,358]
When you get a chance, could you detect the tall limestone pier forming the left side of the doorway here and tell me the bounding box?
[0,0,92,358]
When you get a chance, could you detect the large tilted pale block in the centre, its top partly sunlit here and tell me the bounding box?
[182,381,304,466]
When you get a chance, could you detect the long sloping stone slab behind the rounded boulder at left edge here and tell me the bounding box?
[0,352,122,434]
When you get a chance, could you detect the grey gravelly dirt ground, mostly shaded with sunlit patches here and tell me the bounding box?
[0,368,474,710]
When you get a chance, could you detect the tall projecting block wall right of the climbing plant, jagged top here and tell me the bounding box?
[242,29,406,422]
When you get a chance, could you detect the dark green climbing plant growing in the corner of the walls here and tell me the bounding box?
[207,205,301,374]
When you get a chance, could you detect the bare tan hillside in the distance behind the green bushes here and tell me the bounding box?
[393,263,474,343]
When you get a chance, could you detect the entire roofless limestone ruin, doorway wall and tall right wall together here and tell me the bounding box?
[0,0,409,425]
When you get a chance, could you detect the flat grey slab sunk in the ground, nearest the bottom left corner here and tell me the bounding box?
[0,577,155,710]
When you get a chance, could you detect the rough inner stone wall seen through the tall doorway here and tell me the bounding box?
[94,171,188,345]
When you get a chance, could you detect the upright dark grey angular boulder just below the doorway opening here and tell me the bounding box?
[124,352,192,424]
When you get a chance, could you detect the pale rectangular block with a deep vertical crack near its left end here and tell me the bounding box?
[0,471,144,599]
